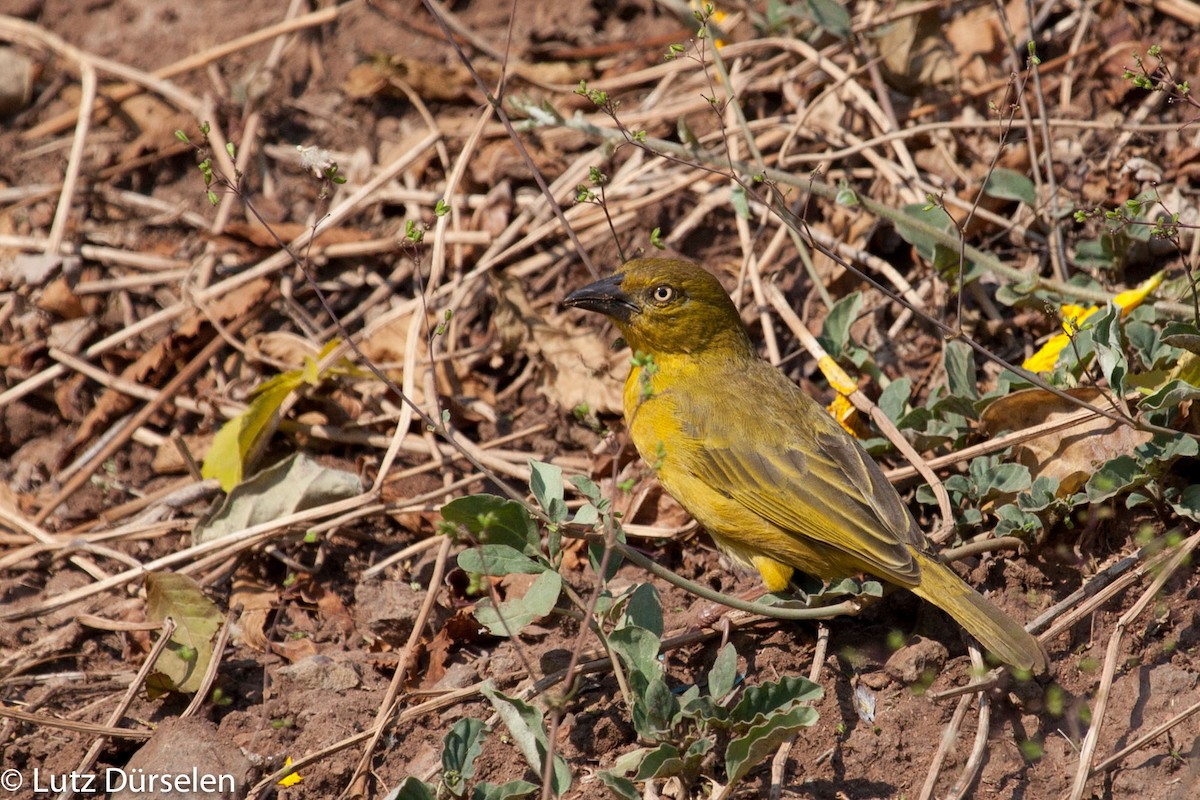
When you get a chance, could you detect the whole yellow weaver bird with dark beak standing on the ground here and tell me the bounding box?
[564,258,1046,673]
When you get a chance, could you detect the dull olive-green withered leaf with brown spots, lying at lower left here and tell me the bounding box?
[146,572,224,699]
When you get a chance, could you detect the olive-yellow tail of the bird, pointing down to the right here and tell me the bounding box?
[911,554,1046,674]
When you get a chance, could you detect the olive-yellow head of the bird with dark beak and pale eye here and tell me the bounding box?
[563,258,752,355]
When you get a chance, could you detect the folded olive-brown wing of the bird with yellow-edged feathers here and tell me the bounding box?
[685,379,926,585]
